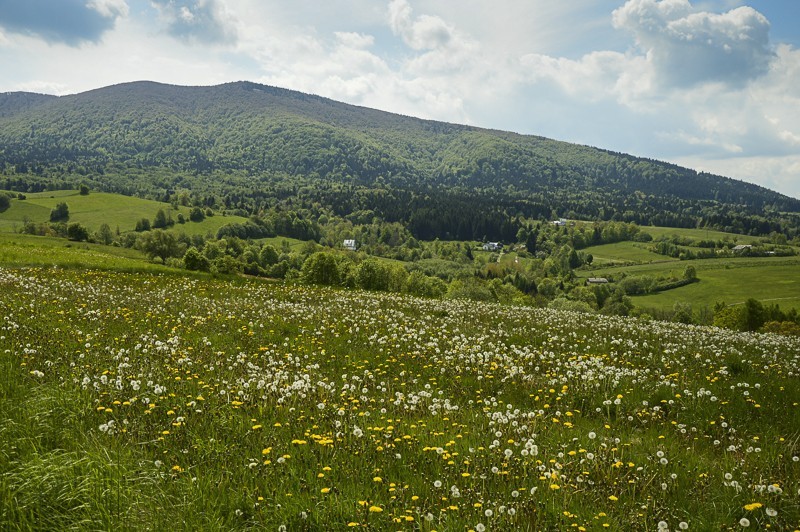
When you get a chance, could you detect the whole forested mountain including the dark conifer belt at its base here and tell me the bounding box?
[0,82,800,238]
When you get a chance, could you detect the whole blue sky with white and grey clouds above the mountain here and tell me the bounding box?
[0,0,800,198]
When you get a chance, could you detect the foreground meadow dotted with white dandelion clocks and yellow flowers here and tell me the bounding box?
[0,268,800,531]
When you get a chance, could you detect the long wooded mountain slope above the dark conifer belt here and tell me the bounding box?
[0,81,800,237]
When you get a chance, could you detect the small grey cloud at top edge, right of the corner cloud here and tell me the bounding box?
[151,0,236,43]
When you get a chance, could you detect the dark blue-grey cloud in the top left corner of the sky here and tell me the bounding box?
[0,0,128,46]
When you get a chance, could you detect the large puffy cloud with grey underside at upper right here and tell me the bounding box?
[613,0,773,87]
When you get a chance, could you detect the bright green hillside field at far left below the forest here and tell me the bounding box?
[0,190,245,235]
